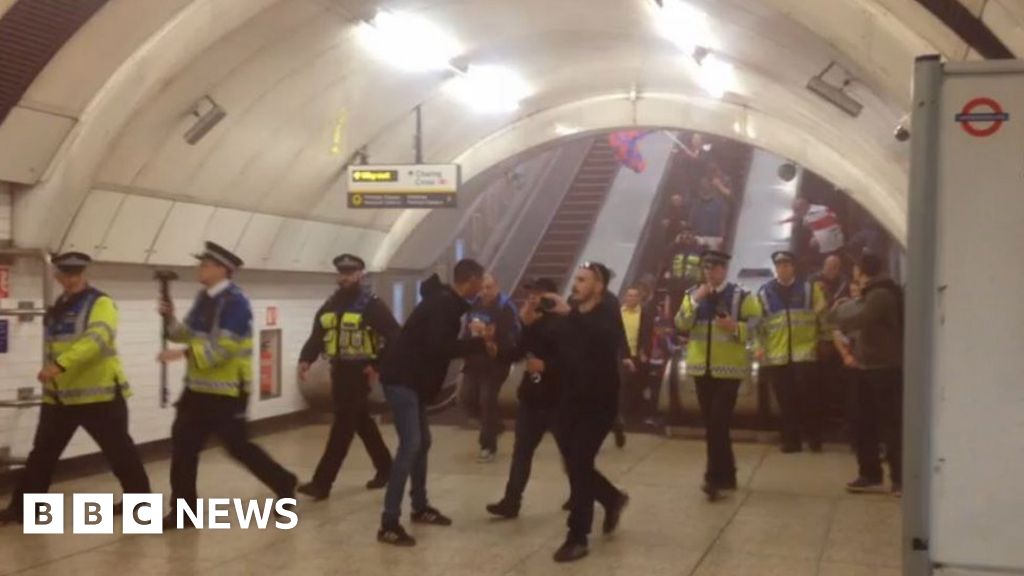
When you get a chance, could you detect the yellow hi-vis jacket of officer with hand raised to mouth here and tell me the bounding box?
[676,283,761,380]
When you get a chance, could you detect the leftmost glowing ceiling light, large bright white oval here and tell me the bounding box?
[358,10,462,72]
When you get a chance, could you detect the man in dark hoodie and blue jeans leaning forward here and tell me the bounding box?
[377,259,498,546]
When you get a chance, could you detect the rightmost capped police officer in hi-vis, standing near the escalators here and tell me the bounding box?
[758,250,827,453]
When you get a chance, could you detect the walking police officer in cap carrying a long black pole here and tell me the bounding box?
[158,242,298,528]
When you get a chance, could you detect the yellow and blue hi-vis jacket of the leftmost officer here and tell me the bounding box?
[43,287,131,406]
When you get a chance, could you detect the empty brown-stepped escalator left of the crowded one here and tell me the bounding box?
[513,137,620,301]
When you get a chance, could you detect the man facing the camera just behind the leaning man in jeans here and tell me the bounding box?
[462,274,519,462]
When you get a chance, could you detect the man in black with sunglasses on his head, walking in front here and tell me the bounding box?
[553,262,630,562]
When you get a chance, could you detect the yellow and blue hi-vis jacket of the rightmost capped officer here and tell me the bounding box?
[758,280,826,366]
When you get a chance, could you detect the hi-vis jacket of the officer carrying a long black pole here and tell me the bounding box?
[168,284,253,398]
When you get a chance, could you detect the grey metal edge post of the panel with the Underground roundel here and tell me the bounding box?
[903,55,943,576]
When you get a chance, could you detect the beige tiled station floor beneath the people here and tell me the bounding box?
[0,425,900,576]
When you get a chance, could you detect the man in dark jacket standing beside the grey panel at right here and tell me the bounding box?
[828,254,903,495]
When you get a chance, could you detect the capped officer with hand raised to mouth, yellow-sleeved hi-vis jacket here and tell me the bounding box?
[676,250,761,501]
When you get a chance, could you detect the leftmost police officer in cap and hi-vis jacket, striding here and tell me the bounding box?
[0,252,150,524]
